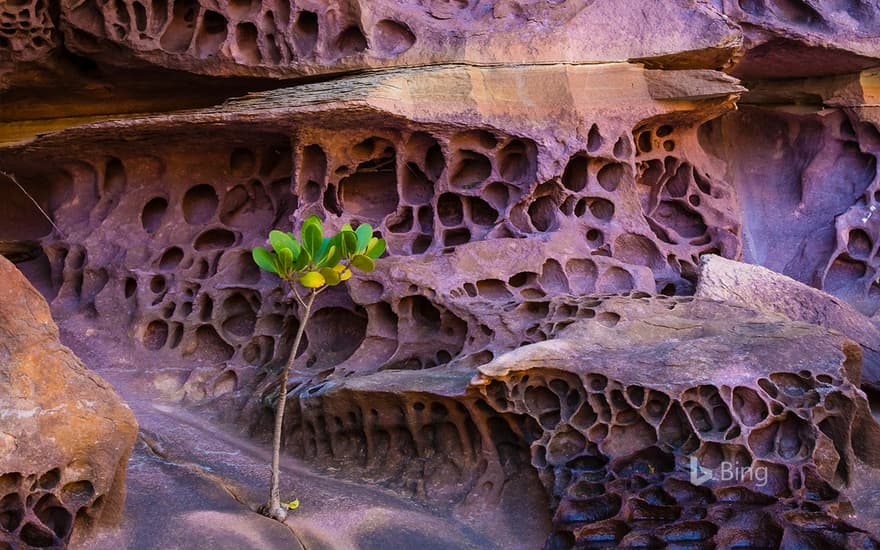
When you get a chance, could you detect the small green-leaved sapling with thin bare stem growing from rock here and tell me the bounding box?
[253,216,385,521]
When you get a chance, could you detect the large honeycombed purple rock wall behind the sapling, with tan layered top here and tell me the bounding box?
[0,65,740,416]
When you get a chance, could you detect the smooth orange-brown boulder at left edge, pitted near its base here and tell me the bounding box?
[0,258,137,548]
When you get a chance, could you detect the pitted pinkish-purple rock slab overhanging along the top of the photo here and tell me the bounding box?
[61,0,741,77]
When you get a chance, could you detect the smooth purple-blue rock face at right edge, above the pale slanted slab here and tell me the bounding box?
[701,99,880,316]
